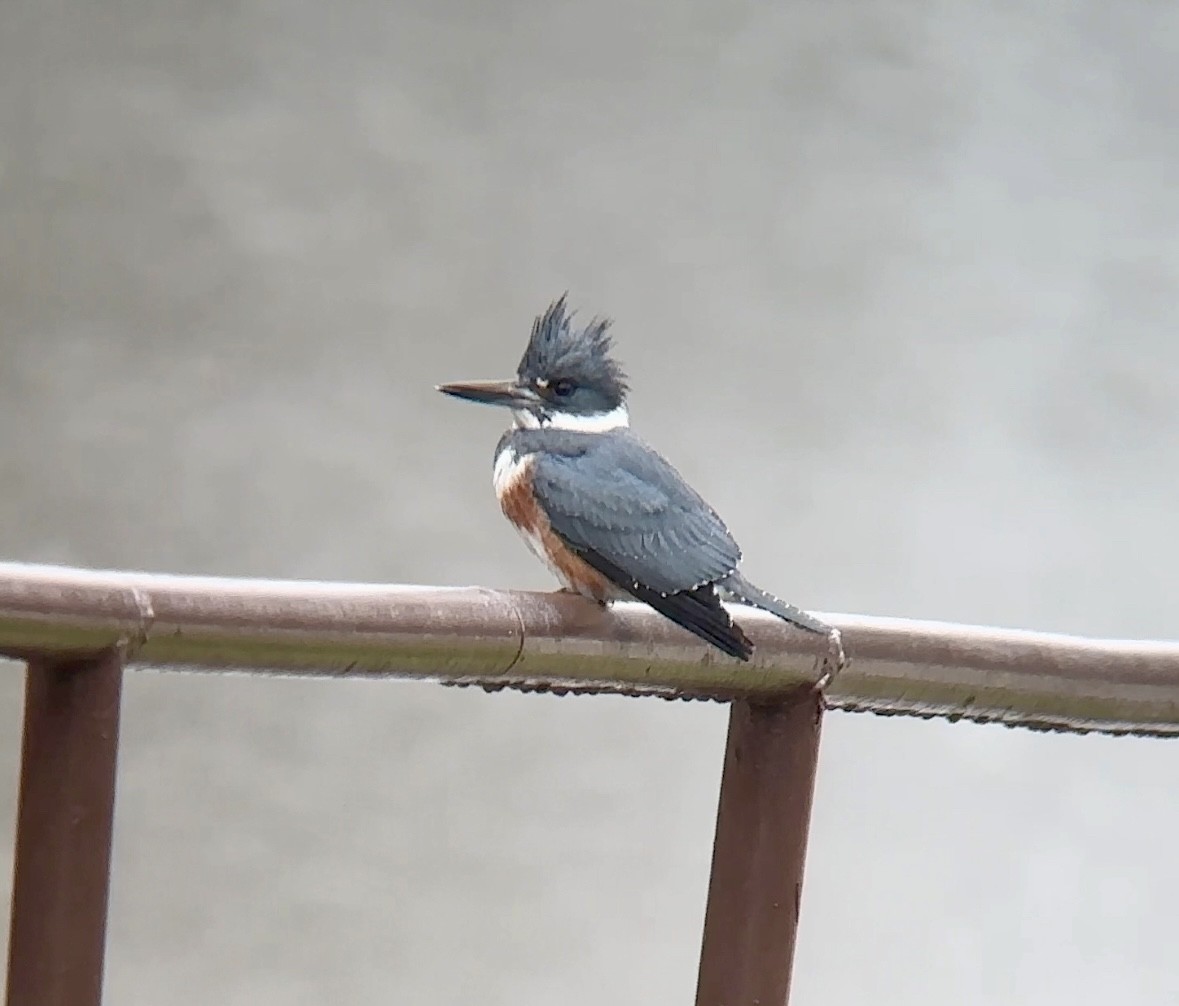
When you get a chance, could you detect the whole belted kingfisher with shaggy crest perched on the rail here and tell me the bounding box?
[437,296,845,684]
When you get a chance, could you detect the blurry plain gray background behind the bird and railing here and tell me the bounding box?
[0,0,1179,1006]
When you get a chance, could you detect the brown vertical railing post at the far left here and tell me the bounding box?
[7,650,123,1006]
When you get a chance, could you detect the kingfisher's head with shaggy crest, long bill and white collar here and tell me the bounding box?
[439,296,628,432]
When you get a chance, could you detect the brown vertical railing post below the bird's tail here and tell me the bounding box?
[696,692,823,1006]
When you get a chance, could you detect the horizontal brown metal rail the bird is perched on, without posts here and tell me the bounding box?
[0,563,1179,736]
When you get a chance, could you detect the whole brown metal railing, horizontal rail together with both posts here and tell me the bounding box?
[0,563,1179,1006]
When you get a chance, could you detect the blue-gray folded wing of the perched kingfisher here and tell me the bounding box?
[533,430,740,593]
